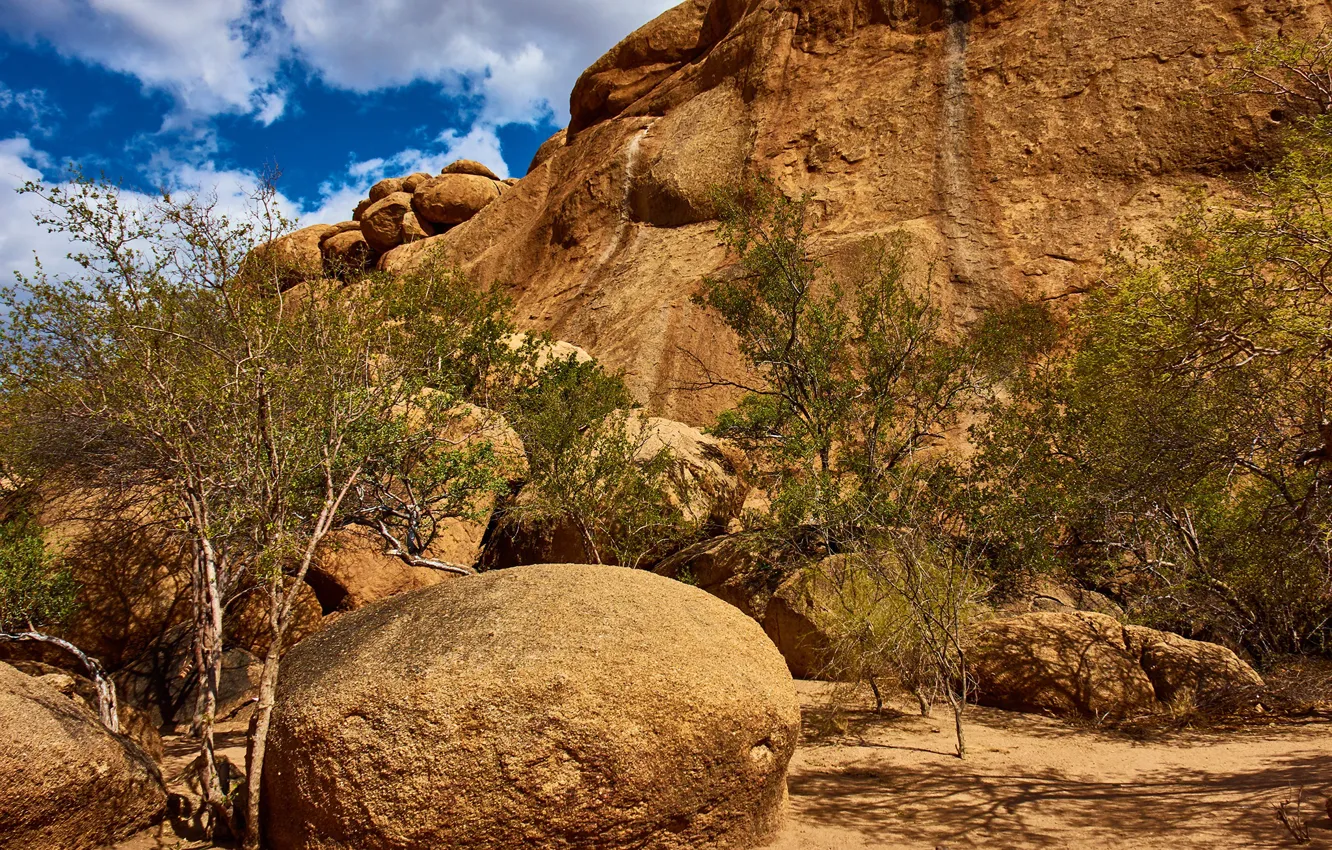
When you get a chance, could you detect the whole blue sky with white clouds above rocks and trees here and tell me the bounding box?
[0,0,675,277]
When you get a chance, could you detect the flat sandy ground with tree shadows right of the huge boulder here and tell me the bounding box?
[770,682,1332,850]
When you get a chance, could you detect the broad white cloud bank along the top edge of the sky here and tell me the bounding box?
[0,0,677,128]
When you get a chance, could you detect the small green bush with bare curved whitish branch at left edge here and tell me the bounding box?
[0,510,120,731]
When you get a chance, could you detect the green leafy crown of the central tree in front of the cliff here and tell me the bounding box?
[695,181,1048,550]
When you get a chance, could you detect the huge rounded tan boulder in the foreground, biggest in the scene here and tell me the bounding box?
[264,565,799,850]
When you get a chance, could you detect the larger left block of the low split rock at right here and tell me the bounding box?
[967,612,1156,718]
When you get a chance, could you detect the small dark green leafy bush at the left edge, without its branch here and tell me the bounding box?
[0,514,79,633]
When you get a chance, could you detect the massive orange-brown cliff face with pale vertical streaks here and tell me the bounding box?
[378,0,1332,425]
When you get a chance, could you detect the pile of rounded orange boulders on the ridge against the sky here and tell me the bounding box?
[261,160,517,289]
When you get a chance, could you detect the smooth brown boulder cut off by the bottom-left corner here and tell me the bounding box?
[0,663,167,850]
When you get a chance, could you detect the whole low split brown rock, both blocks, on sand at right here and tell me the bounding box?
[968,612,1263,717]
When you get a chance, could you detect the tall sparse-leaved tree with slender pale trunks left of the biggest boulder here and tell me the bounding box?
[0,179,511,846]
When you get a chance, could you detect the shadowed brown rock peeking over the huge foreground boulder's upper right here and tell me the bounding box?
[653,534,785,618]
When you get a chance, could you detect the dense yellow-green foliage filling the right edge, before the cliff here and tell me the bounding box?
[976,109,1332,658]
